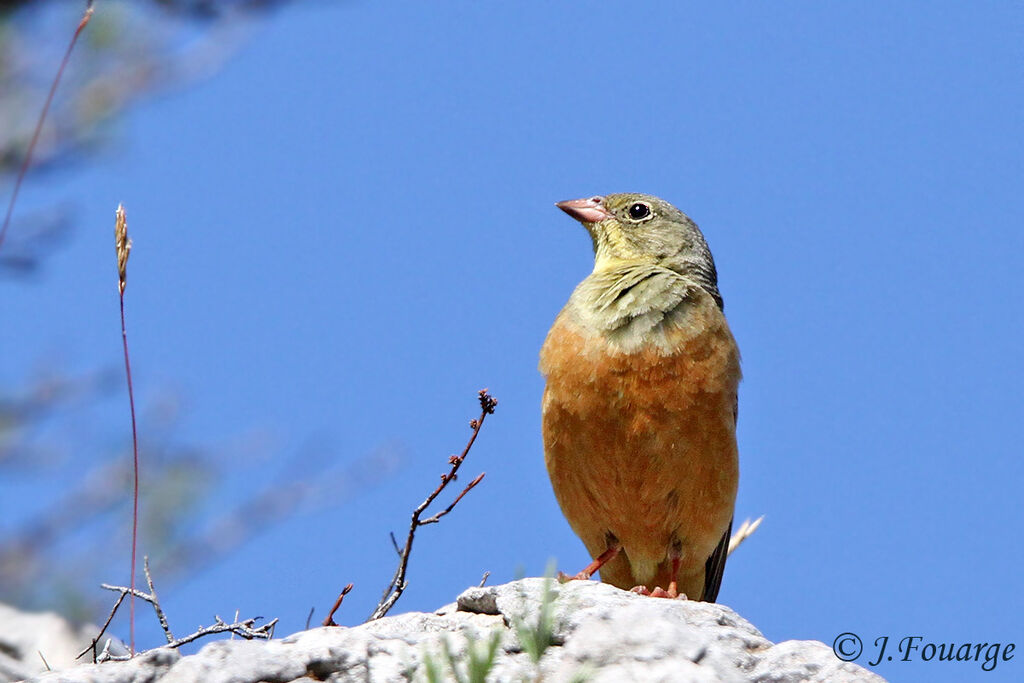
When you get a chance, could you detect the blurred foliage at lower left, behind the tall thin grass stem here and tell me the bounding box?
[0,361,399,621]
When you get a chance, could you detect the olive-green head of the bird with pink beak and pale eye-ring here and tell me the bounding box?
[555,193,721,306]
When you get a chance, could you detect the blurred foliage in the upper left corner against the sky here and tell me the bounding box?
[0,0,286,278]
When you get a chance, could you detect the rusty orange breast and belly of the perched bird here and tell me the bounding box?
[541,298,740,596]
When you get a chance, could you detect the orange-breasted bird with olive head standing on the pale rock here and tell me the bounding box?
[540,193,741,602]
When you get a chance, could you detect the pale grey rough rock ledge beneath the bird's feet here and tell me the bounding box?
[6,579,883,683]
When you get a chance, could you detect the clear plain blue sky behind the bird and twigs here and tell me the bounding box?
[0,1,1024,681]
